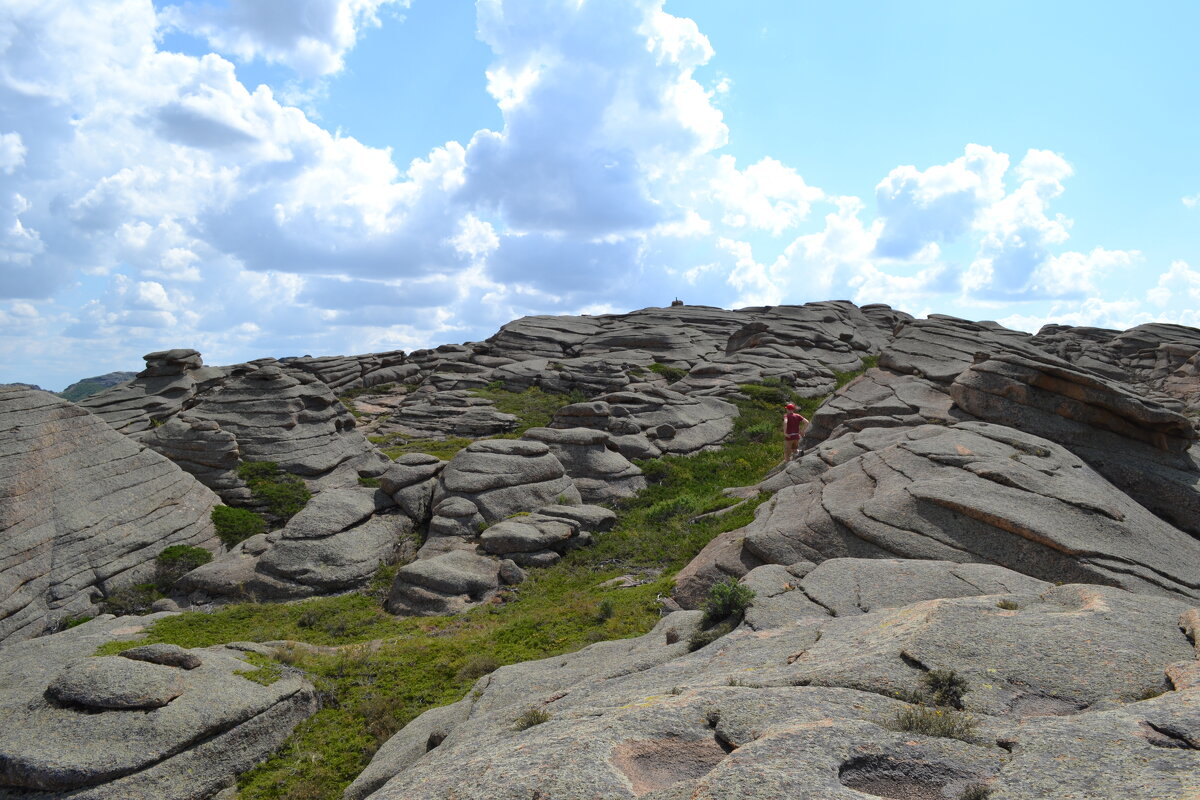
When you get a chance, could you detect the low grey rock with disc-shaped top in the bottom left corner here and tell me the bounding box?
[0,616,317,800]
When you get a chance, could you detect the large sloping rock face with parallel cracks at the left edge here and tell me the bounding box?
[0,390,220,642]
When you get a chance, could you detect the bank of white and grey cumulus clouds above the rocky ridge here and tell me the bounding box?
[0,0,1182,384]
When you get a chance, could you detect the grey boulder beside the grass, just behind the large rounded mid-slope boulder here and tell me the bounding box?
[523,426,643,503]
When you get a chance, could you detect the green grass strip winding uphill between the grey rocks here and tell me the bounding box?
[91,364,873,800]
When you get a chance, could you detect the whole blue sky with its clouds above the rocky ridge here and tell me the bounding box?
[0,0,1200,390]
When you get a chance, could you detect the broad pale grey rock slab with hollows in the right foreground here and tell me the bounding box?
[346,561,1200,800]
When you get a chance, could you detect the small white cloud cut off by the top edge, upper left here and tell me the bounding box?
[161,0,412,78]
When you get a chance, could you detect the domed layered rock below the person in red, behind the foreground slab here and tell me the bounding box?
[676,422,1200,604]
